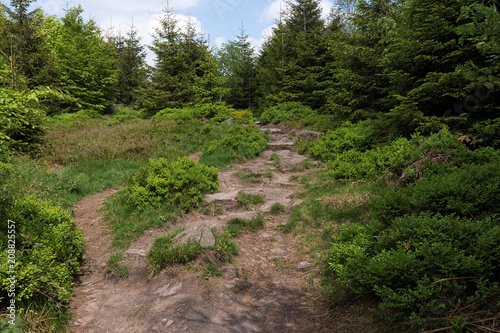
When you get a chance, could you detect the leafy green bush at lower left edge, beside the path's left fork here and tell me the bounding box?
[0,196,83,307]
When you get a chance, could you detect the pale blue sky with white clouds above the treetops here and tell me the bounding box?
[35,0,332,62]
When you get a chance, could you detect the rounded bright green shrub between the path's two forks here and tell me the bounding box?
[127,157,219,209]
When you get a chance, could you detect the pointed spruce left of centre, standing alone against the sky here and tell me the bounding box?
[139,8,218,114]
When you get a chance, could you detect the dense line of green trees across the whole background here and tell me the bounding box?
[0,0,500,145]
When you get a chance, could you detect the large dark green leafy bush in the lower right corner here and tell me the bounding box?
[328,214,500,319]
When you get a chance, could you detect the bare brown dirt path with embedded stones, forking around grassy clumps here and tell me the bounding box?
[71,127,327,333]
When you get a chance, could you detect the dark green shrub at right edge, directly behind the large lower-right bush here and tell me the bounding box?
[372,162,500,220]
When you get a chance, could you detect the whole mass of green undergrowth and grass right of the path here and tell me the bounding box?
[292,122,500,332]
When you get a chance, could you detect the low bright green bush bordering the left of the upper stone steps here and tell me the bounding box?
[200,125,267,167]
